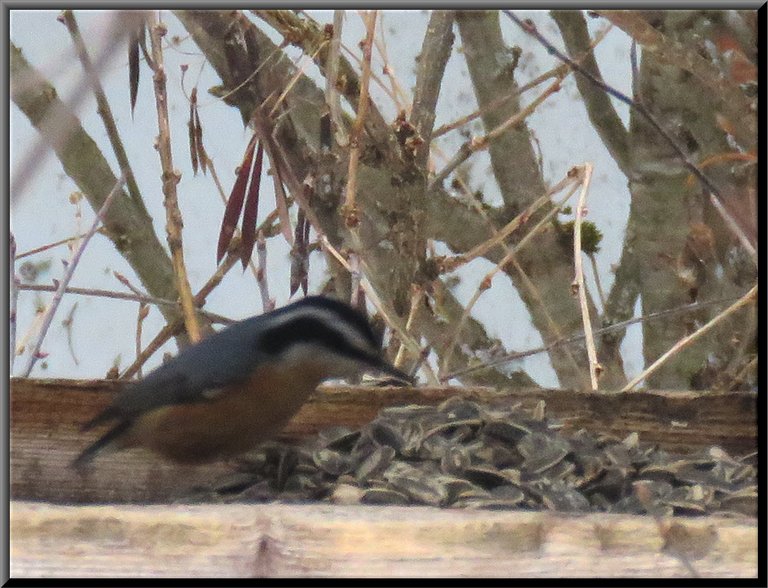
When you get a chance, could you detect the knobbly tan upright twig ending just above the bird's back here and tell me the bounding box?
[150,14,200,343]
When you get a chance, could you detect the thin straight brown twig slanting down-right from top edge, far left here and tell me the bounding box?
[60,10,149,216]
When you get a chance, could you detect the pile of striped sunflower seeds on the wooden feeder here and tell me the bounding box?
[180,397,757,516]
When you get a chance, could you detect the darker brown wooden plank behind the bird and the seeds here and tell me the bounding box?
[10,378,757,503]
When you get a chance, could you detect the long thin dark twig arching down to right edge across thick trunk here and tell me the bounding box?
[502,10,757,265]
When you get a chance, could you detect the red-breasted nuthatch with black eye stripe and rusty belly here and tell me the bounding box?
[73,296,411,467]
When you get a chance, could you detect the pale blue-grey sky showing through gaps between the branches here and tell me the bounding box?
[10,10,642,387]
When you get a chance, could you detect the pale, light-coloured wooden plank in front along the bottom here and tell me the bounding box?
[10,502,758,578]
